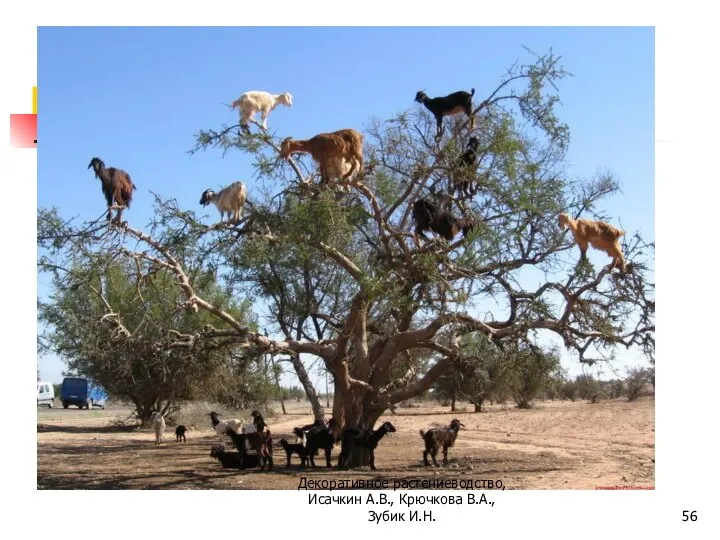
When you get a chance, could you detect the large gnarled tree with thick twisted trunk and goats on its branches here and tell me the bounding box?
[38,52,654,464]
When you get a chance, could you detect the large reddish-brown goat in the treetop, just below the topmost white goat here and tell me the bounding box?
[280,129,363,184]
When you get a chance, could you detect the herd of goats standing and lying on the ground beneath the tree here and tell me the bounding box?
[150,411,465,471]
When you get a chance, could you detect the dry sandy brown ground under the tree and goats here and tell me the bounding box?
[37,397,655,489]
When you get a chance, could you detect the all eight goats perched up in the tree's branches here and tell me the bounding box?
[88,88,631,273]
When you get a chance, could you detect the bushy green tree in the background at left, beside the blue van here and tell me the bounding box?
[39,254,262,421]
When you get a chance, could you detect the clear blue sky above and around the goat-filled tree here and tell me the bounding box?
[38,27,655,391]
